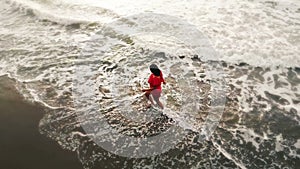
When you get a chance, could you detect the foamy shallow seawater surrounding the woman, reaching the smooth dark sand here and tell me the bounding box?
[0,0,300,168]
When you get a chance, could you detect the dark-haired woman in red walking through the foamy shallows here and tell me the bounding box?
[143,64,166,109]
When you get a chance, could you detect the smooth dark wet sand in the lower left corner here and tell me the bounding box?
[0,77,83,169]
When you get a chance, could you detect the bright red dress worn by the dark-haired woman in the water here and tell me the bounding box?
[148,72,165,97]
